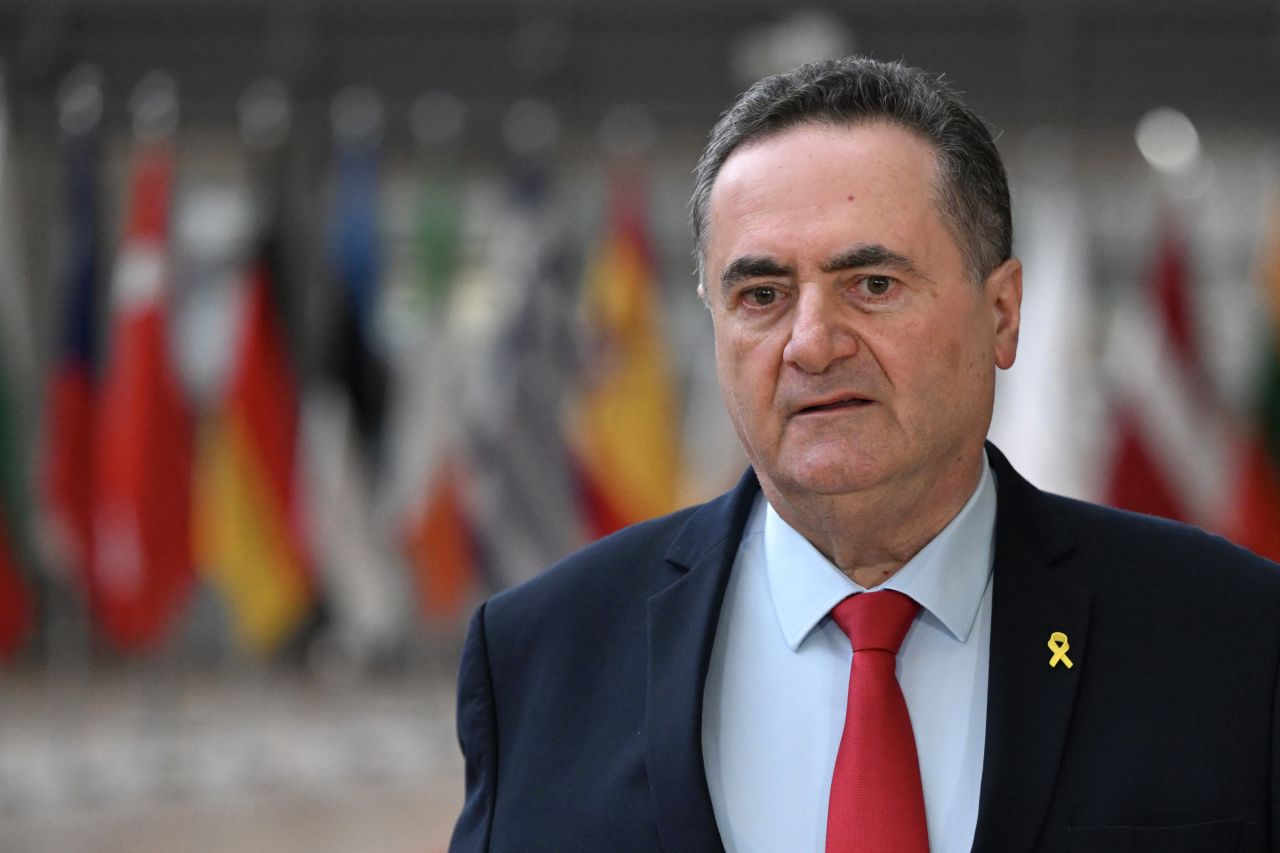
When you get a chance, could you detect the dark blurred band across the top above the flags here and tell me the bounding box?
[0,0,1280,151]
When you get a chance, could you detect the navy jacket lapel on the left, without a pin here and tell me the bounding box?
[645,470,759,853]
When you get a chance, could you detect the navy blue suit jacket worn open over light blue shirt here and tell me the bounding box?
[451,446,1280,853]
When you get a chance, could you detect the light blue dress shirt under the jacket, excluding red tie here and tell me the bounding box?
[703,458,996,853]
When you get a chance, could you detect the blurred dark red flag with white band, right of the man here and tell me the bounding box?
[1103,220,1229,525]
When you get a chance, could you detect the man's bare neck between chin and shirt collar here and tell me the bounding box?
[760,448,987,589]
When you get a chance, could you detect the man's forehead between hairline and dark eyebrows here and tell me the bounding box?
[708,122,941,255]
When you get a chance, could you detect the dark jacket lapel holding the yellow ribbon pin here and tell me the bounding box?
[973,444,1089,853]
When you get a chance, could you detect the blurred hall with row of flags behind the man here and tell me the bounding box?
[0,0,1280,850]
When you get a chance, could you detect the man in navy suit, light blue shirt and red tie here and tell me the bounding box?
[452,58,1280,853]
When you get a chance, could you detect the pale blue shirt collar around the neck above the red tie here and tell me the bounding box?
[750,465,996,652]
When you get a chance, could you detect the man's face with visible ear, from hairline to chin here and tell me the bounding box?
[704,123,1021,497]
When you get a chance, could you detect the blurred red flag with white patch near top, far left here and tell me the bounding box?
[91,140,193,651]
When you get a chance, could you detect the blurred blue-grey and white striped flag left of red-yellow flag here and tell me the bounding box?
[465,167,585,585]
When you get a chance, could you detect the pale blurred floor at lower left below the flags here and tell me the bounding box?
[0,670,462,853]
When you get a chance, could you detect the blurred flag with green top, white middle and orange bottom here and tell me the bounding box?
[389,152,477,625]
